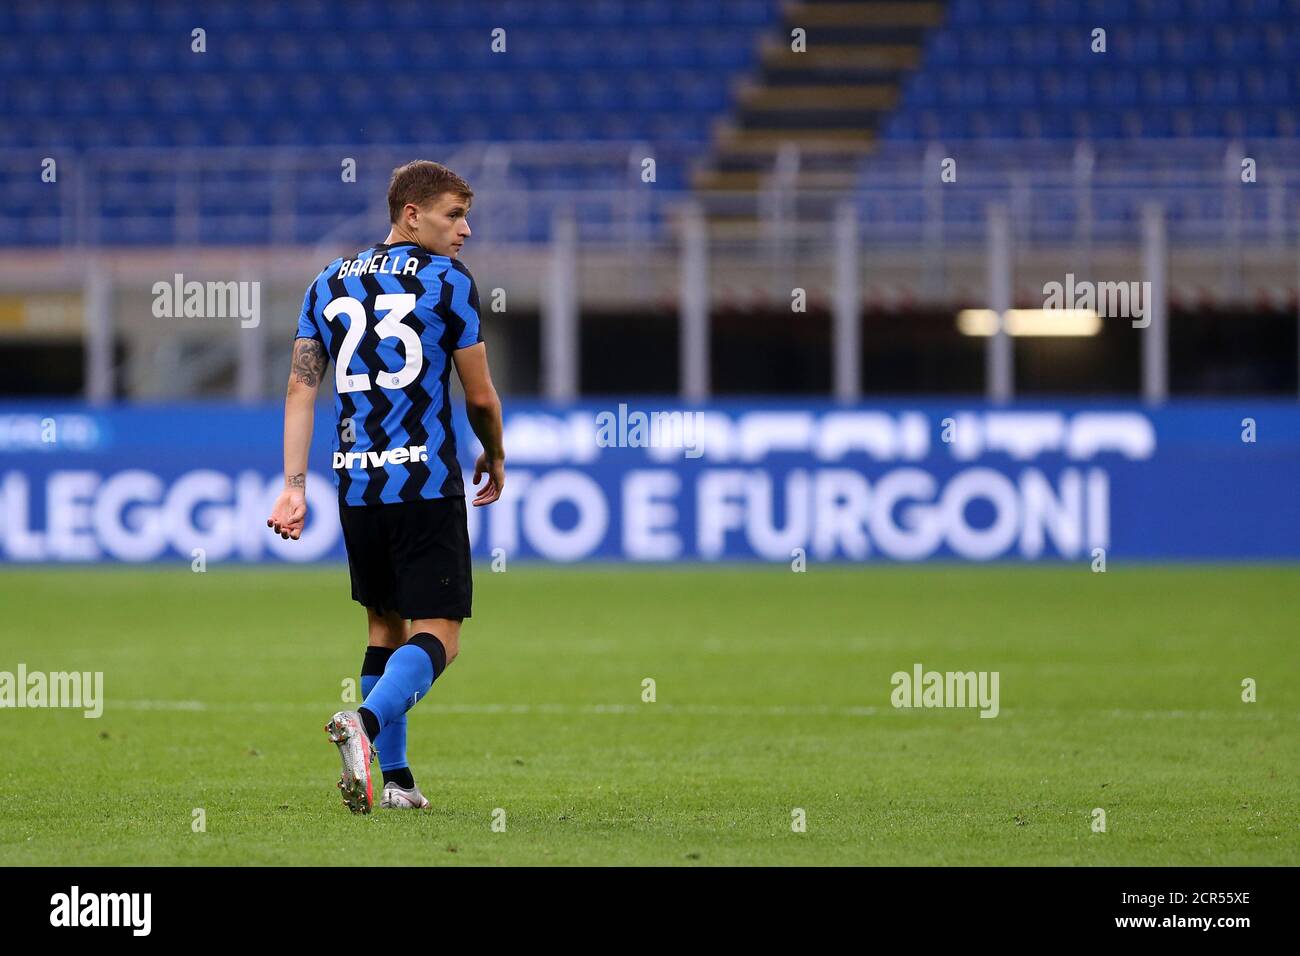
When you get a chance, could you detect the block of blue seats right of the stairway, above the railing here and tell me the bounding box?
[884,0,1300,153]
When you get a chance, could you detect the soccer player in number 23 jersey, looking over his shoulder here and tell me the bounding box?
[267,160,506,813]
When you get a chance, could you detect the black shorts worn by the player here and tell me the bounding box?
[338,497,475,620]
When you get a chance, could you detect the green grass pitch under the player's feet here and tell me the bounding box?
[0,562,1300,866]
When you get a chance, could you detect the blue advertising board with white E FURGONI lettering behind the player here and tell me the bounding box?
[0,399,1300,563]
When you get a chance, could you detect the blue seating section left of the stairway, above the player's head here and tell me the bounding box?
[0,0,779,245]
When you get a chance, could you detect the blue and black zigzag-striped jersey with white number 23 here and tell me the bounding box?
[298,242,482,505]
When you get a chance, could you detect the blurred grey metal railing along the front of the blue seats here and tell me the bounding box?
[0,140,1300,250]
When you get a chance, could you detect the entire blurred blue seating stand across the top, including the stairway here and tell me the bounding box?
[0,0,1300,246]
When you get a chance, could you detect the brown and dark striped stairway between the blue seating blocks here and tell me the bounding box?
[692,0,944,225]
